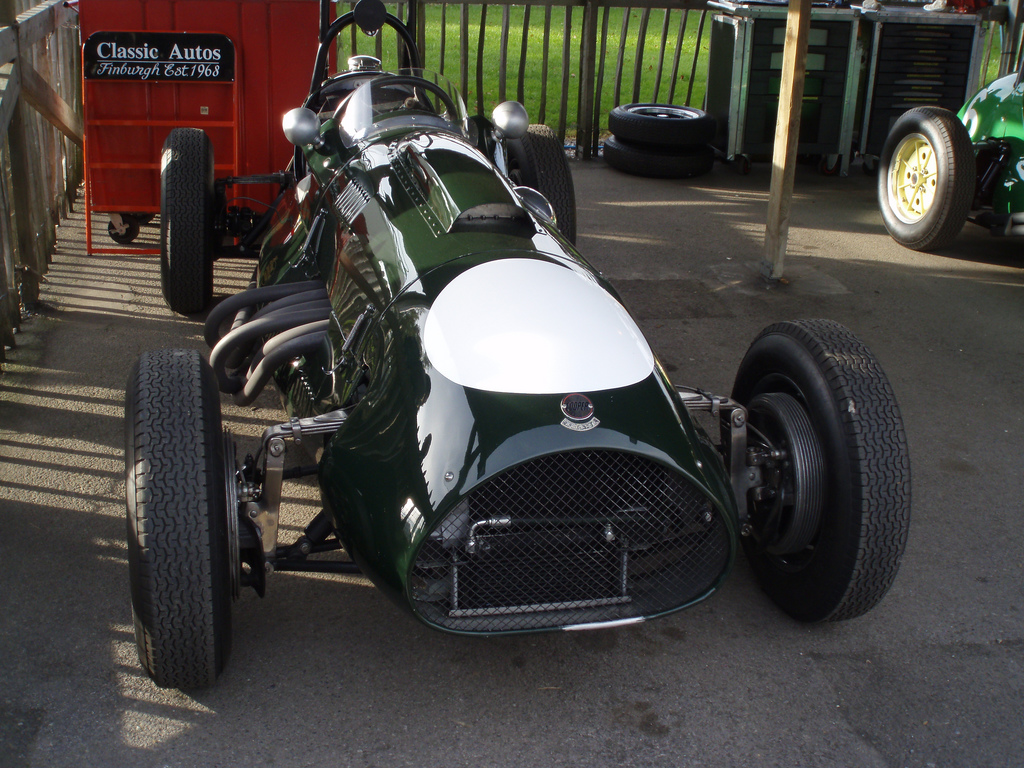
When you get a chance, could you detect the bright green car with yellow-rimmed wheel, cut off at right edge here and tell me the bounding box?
[879,62,1024,251]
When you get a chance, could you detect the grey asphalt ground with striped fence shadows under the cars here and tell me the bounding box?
[0,157,1024,768]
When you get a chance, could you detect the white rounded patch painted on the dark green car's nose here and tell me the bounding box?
[424,258,654,394]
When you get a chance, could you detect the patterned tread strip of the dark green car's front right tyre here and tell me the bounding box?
[737,319,910,621]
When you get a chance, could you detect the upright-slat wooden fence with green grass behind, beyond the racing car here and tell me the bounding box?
[343,0,710,159]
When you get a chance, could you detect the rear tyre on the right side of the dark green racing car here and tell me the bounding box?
[506,125,577,244]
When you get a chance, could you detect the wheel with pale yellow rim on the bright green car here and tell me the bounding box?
[879,106,977,251]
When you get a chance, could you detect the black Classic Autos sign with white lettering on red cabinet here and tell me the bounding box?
[82,32,234,82]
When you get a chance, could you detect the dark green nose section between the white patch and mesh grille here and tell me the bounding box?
[321,262,736,618]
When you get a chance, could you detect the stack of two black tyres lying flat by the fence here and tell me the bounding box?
[604,103,716,178]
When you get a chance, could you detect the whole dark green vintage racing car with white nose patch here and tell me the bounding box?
[126,0,910,688]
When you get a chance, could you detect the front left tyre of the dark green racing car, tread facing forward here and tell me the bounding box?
[125,349,237,689]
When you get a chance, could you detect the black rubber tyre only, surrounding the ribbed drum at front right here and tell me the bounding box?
[733,321,910,622]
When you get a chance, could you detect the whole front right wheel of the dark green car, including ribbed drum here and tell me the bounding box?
[733,321,910,622]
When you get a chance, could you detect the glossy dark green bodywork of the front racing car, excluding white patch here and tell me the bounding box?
[258,100,738,626]
